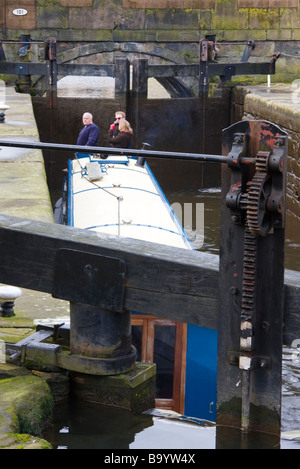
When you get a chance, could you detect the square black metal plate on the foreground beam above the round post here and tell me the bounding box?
[52,249,126,312]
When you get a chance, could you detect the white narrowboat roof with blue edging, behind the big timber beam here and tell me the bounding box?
[68,154,192,249]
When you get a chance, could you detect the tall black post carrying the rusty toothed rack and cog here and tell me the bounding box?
[217,121,287,436]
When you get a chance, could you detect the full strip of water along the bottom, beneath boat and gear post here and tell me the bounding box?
[43,400,300,451]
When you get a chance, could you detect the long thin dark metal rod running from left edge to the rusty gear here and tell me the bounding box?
[0,140,227,163]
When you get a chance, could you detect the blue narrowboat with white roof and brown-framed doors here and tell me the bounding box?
[66,153,217,421]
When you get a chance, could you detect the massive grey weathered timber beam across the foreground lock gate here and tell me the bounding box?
[0,211,300,340]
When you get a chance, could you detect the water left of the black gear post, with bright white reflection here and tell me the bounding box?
[43,400,215,449]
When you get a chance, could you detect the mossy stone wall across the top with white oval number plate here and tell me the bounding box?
[0,0,300,81]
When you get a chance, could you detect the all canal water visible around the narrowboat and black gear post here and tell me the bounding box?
[43,188,300,448]
